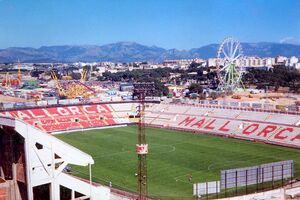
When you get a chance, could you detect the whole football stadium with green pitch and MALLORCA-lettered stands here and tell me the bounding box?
[0,101,300,199]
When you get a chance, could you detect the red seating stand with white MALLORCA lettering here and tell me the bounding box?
[0,103,135,133]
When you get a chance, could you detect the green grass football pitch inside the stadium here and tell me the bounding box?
[57,126,300,199]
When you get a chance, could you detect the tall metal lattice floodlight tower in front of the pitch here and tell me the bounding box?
[133,83,154,200]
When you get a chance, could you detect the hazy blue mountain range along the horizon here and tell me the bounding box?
[0,42,300,63]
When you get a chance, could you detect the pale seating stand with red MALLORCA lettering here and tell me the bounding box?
[145,104,300,148]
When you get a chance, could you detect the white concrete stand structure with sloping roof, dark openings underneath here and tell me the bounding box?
[0,117,110,200]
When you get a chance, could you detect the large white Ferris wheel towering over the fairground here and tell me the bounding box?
[217,37,245,91]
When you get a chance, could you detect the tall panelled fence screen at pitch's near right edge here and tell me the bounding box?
[193,160,300,199]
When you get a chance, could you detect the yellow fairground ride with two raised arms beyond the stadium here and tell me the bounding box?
[50,69,95,99]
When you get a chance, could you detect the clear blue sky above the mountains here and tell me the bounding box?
[0,0,300,49]
